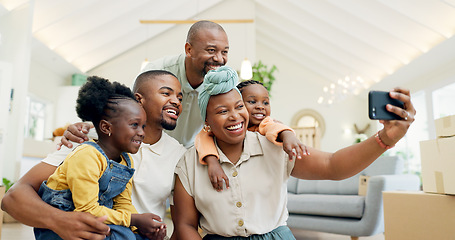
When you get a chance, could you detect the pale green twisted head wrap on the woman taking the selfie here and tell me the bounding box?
[198,66,242,120]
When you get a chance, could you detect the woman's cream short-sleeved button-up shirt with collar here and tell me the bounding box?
[175,132,295,236]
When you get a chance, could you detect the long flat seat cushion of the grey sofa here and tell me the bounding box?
[287,193,365,219]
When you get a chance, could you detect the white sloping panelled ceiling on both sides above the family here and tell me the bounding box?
[0,0,455,88]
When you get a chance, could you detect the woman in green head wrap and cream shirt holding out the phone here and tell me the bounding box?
[172,67,415,240]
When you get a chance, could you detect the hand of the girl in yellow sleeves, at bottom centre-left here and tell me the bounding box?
[131,213,166,239]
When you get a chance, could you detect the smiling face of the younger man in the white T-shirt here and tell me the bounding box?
[136,74,183,130]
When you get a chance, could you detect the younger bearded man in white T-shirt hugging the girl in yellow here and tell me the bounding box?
[2,70,186,239]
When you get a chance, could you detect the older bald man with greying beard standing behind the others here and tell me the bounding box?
[142,21,229,148]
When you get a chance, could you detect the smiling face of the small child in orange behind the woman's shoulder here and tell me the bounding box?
[242,84,271,127]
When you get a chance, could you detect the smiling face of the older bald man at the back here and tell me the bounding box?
[185,28,229,76]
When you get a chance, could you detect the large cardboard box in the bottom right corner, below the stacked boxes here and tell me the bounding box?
[383,191,455,240]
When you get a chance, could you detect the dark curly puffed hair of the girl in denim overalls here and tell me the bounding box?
[76,76,137,126]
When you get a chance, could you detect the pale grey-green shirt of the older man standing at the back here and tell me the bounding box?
[142,53,204,148]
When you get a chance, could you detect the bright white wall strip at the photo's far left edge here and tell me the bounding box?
[0,1,33,179]
